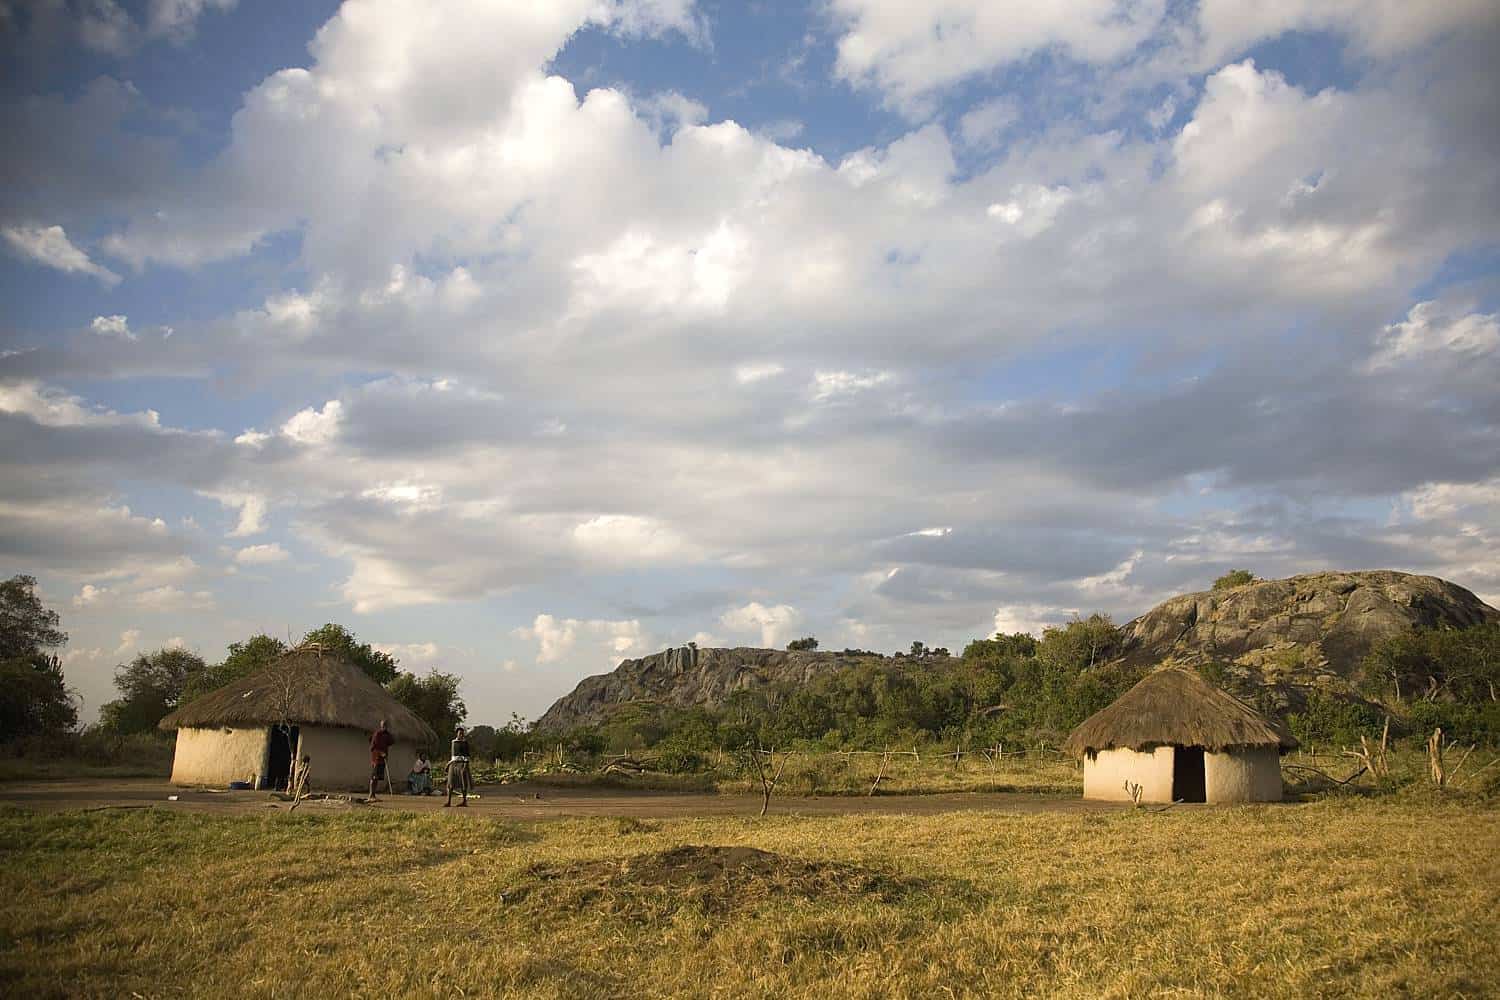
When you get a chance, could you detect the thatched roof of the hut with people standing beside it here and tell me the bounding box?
[161,648,438,745]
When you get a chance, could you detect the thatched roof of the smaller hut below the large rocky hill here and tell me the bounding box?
[1064,667,1298,756]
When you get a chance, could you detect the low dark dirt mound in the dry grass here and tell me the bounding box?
[506,847,927,916]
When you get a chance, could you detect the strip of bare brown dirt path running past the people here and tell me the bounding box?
[0,778,1121,820]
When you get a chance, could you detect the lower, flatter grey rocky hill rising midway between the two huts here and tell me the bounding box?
[537,646,876,730]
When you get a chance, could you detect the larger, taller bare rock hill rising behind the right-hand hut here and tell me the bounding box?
[1125,570,1500,687]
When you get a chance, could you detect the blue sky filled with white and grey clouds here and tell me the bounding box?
[0,0,1500,724]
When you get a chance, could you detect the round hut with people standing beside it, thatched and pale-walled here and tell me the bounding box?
[161,646,438,789]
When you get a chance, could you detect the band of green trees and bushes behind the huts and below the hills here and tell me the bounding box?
[0,571,1500,766]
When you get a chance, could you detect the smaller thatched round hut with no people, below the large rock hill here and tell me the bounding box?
[1064,667,1298,802]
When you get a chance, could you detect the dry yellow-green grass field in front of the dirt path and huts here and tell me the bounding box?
[0,796,1500,997]
